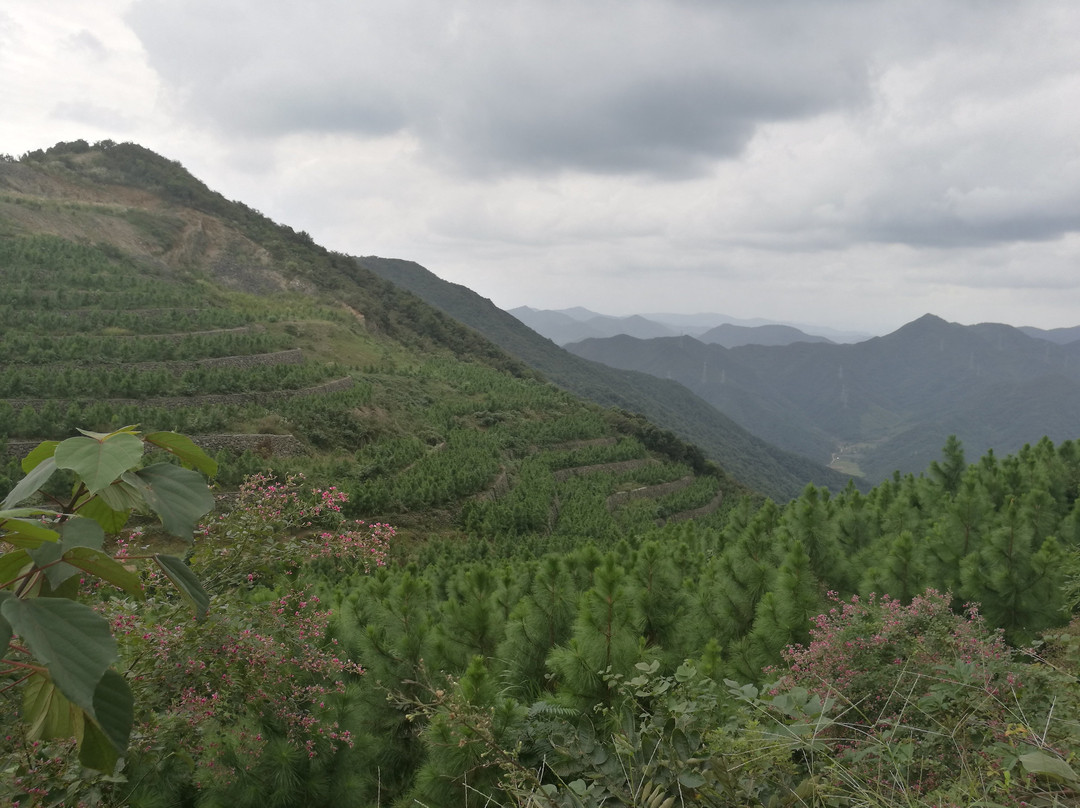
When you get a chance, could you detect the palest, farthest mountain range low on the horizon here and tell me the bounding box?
[509,306,870,348]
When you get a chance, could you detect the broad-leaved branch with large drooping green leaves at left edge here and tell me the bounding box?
[0,427,217,771]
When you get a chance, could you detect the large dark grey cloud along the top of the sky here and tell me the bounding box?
[130,0,867,175]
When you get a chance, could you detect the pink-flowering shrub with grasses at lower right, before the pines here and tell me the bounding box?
[746,590,1078,805]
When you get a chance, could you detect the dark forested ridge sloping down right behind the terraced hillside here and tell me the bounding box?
[357,256,849,500]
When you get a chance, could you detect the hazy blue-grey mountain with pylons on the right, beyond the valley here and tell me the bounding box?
[568,314,1080,482]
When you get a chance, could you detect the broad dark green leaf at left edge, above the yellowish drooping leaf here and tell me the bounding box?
[0,597,118,710]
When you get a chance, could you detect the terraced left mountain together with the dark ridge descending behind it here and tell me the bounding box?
[0,142,847,529]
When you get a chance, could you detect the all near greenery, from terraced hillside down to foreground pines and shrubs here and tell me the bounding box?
[6,143,1080,808]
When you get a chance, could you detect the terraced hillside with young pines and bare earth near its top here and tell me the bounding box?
[0,143,760,541]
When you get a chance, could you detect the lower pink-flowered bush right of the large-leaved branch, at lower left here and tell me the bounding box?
[108,590,363,793]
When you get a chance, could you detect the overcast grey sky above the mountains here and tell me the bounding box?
[0,0,1080,334]
